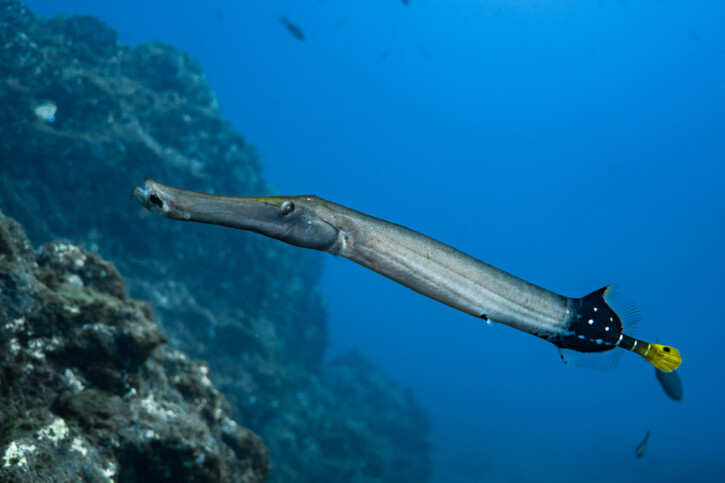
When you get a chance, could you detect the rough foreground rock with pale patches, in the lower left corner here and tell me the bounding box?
[0,212,269,482]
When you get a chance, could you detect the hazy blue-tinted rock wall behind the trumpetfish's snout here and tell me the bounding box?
[0,0,430,482]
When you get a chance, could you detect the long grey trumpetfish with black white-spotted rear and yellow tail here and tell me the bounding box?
[132,179,682,372]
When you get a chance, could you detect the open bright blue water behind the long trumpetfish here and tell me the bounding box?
[22,0,725,482]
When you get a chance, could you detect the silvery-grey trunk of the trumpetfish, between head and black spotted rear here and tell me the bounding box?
[320,200,573,337]
